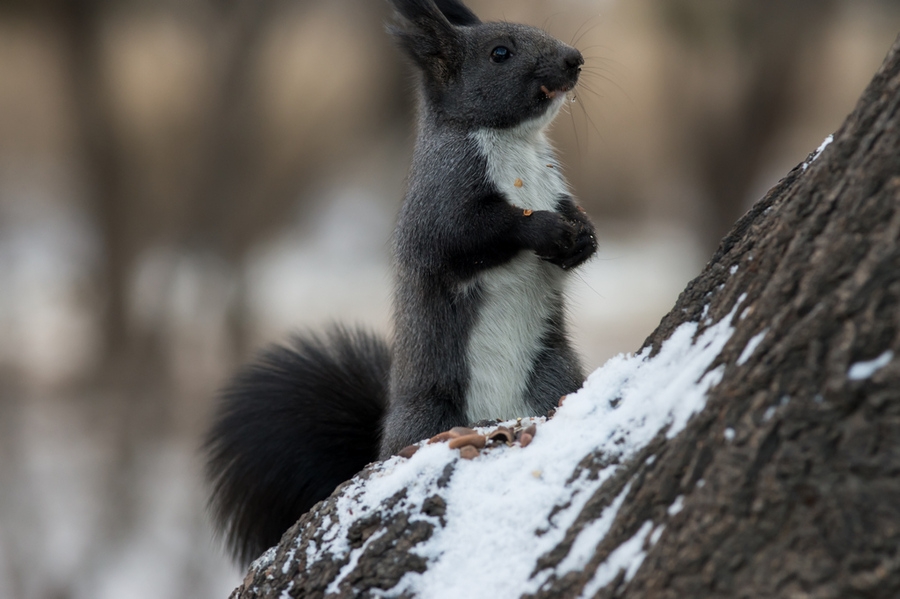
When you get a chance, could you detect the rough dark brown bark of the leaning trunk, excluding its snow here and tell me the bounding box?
[227,39,900,599]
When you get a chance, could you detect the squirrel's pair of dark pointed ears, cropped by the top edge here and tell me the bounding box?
[388,0,480,83]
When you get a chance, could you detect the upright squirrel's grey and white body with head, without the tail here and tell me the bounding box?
[381,0,596,457]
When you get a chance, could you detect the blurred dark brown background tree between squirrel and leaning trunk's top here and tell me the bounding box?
[657,0,837,251]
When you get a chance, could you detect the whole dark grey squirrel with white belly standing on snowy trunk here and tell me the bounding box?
[206,0,597,563]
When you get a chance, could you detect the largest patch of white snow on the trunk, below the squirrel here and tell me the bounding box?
[308,305,737,598]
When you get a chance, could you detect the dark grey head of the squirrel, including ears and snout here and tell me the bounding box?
[390,0,584,128]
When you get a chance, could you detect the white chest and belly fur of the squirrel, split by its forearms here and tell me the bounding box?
[466,124,568,422]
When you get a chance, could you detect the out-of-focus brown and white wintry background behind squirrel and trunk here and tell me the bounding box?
[0,0,900,599]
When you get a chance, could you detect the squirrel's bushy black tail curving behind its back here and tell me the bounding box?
[206,327,390,564]
